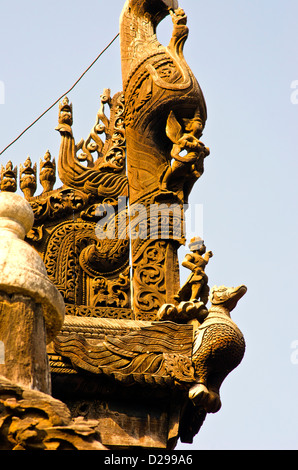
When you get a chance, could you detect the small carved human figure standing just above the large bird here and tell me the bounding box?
[175,237,213,305]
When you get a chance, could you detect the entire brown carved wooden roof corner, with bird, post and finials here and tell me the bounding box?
[0,0,246,449]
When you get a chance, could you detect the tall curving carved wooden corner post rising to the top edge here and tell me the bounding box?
[120,0,209,319]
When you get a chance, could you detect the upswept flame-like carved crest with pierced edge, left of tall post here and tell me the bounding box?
[57,90,127,197]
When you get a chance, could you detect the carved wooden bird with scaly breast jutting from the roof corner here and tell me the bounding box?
[189,285,247,413]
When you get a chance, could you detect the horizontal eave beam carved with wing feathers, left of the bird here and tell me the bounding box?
[49,315,195,390]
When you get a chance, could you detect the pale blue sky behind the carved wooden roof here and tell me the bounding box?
[0,0,298,450]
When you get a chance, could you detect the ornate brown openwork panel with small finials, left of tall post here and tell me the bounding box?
[1,89,133,319]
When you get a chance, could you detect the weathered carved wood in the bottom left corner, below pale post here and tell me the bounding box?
[0,376,106,451]
